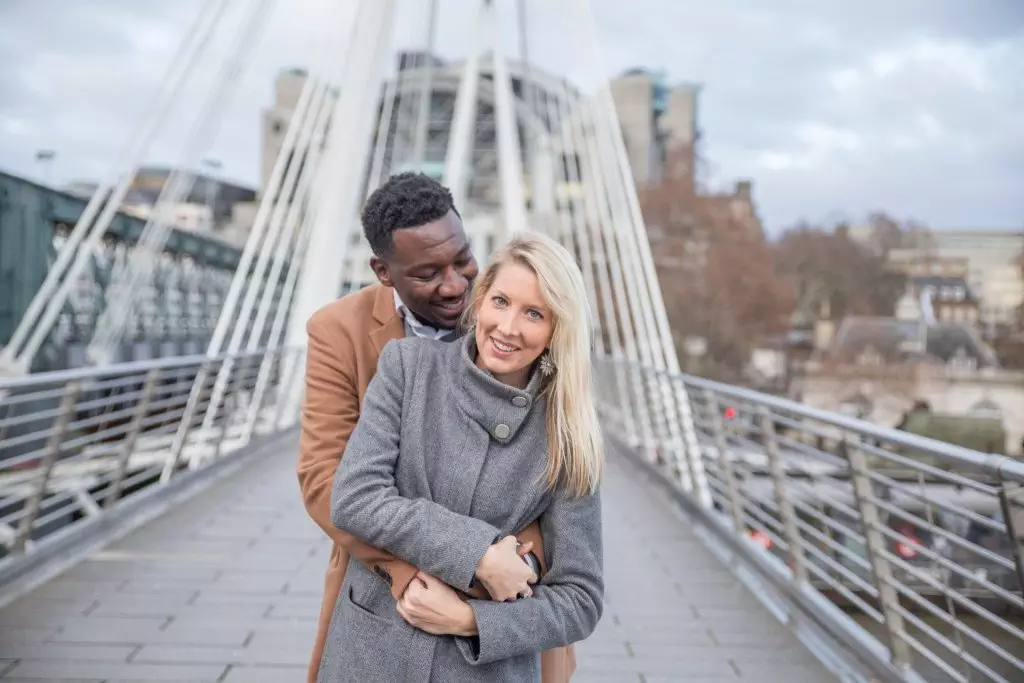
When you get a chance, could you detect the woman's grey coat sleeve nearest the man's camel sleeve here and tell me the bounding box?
[331,341,501,591]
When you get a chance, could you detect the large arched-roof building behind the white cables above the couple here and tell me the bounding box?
[261,52,610,286]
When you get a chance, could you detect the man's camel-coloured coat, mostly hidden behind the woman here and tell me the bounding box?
[298,285,575,683]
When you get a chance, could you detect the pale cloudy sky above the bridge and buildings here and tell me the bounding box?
[0,0,1024,231]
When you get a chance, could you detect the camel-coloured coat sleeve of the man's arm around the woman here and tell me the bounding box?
[298,313,417,599]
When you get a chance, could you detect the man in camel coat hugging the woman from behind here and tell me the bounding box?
[298,173,575,683]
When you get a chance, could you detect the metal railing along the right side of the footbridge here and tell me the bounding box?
[598,360,1024,682]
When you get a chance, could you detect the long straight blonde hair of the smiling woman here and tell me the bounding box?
[465,232,604,496]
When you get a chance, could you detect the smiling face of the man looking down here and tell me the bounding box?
[370,211,479,330]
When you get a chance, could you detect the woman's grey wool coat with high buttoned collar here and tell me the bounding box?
[319,335,604,683]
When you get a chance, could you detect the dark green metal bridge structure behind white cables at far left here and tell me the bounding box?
[0,172,242,373]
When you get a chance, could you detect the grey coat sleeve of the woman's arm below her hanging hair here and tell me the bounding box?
[456,489,604,665]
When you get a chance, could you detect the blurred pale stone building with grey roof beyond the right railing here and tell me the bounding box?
[790,294,1024,455]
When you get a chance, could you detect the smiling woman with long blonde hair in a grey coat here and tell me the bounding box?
[319,234,604,683]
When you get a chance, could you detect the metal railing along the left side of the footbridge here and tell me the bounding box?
[0,349,304,569]
